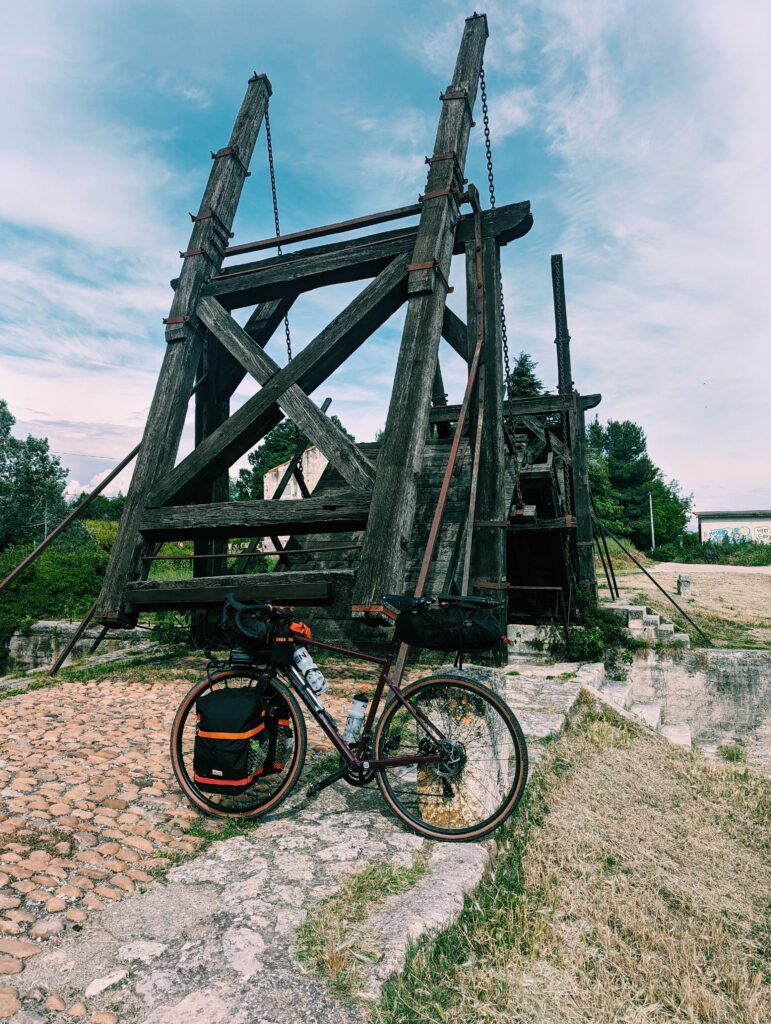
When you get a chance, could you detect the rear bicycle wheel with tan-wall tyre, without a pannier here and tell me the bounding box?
[374,676,527,842]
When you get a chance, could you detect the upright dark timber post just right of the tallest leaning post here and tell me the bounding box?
[466,238,508,635]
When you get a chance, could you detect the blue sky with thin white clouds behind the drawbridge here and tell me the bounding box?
[0,0,771,509]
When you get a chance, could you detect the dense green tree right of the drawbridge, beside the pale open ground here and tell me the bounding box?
[587,418,692,549]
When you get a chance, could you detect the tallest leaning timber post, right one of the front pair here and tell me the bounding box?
[352,14,487,616]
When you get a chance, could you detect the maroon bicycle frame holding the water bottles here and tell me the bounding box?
[284,639,445,771]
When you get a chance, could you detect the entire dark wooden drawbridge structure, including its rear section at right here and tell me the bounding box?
[90,14,599,639]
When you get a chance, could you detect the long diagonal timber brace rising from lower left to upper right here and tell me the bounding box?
[148,254,408,506]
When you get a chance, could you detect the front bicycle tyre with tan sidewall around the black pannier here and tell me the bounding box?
[170,669,307,818]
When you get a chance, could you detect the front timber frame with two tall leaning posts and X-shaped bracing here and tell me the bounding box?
[96,14,532,626]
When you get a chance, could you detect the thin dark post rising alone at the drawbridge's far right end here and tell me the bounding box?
[552,254,597,600]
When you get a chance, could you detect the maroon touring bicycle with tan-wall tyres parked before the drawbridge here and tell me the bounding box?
[171,596,527,841]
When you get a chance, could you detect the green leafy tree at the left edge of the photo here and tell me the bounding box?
[0,399,67,551]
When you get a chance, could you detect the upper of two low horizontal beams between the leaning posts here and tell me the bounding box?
[140,490,370,542]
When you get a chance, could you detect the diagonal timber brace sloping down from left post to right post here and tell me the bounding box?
[198,297,375,490]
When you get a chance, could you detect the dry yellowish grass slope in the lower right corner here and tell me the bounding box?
[378,706,771,1024]
